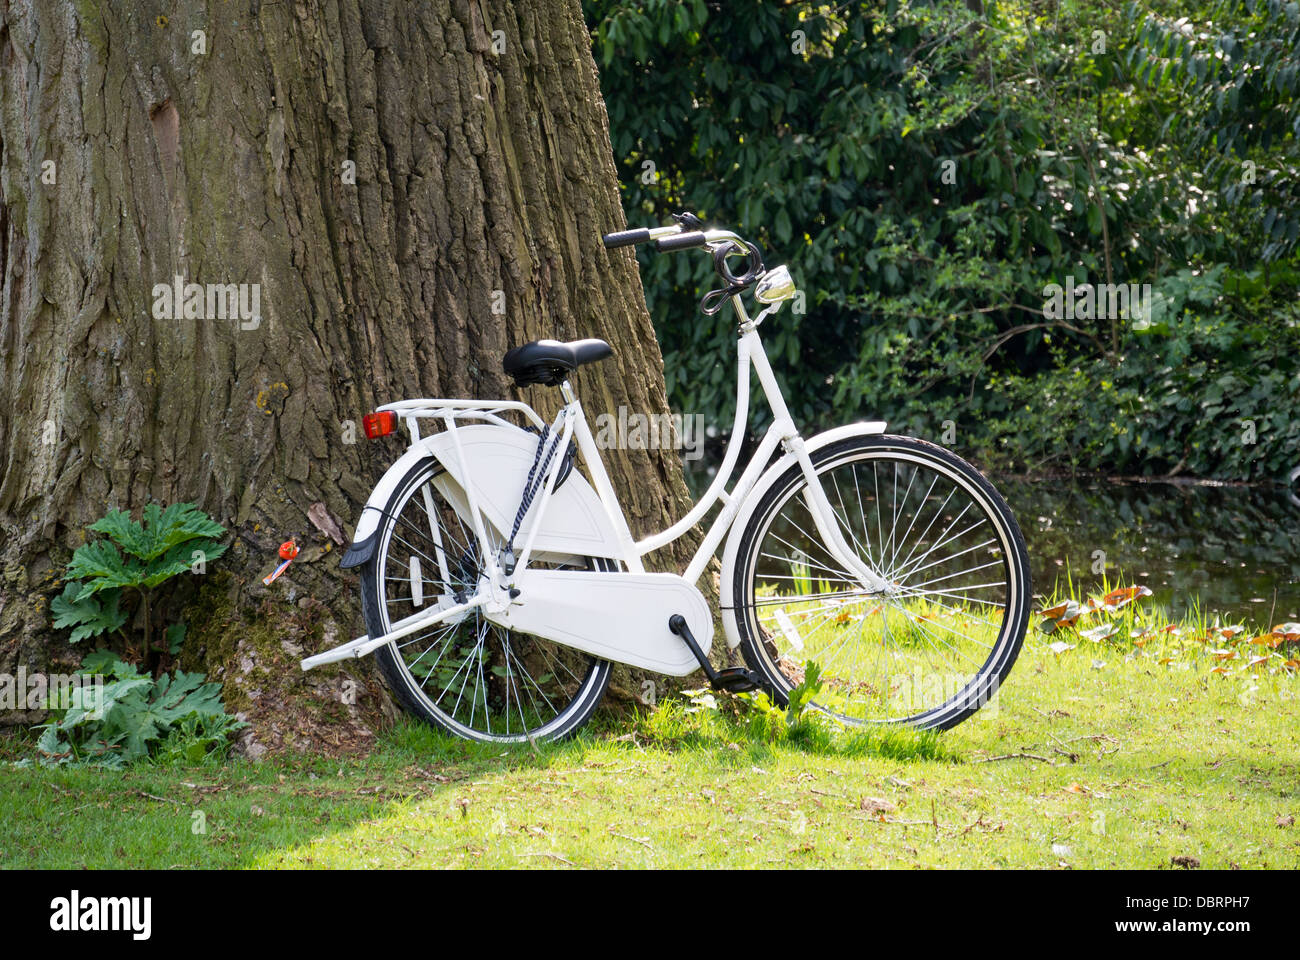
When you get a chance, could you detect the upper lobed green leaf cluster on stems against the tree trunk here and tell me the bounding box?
[49,503,226,662]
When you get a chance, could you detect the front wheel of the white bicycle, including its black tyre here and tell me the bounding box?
[732,436,1031,730]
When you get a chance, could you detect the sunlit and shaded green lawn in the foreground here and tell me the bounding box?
[0,611,1300,869]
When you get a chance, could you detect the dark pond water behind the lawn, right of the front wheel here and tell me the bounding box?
[686,459,1300,626]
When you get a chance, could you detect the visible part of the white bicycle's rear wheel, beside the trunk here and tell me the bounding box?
[360,458,611,743]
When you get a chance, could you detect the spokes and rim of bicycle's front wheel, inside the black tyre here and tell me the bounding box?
[745,444,1011,722]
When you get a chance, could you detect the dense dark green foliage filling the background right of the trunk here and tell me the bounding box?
[584,0,1300,479]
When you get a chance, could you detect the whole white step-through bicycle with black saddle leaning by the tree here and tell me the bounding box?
[302,215,1031,743]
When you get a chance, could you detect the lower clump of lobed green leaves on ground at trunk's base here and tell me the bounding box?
[36,650,246,767]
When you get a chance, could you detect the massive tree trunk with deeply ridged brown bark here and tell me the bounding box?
[0,0,690,748]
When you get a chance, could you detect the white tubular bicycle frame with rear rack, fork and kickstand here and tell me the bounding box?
[303,273,887,670]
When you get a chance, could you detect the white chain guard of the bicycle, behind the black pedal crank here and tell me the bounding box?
[488,570,714,676]
